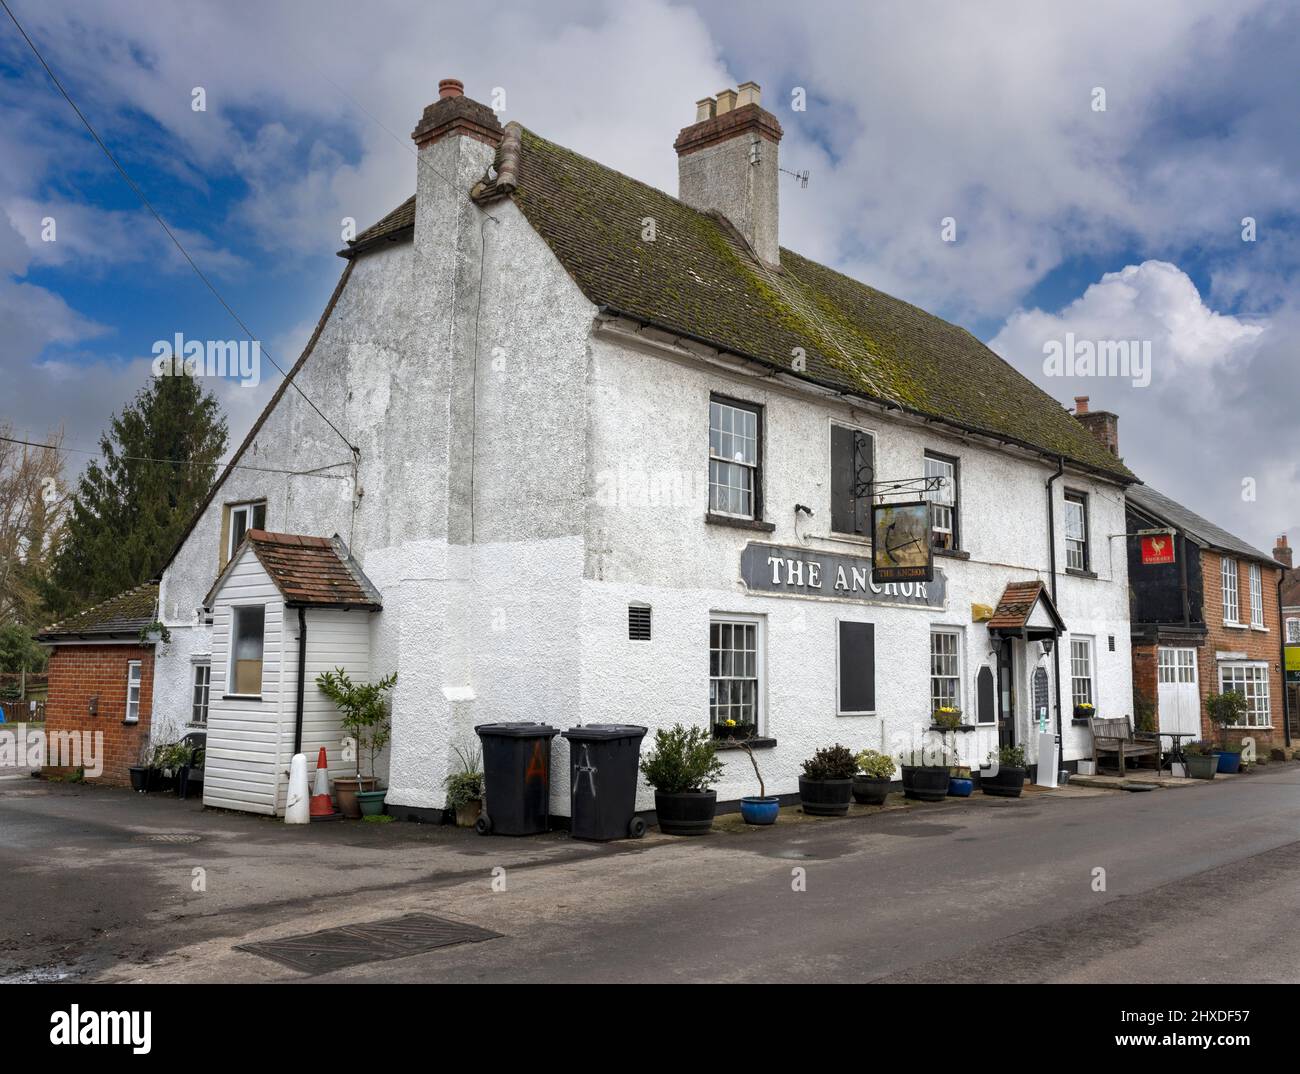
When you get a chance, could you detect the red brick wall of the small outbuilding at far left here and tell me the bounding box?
[46,645,153,784]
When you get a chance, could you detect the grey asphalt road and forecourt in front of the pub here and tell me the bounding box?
[0,765,1300,982]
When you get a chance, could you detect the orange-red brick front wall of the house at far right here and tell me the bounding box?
[1199,549,1284,757]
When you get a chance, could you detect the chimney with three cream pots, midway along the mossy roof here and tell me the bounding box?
[672,82,783,265]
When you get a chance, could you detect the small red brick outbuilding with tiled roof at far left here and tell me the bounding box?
[36,583,159,785]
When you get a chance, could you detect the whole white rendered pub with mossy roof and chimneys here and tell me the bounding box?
[147,79,1135,818]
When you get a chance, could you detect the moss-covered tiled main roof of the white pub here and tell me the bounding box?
[347,125,1136,481]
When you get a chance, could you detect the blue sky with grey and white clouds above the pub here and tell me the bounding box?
[0,0,1300,549]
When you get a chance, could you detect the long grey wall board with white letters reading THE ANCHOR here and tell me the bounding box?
[740,541,948,609]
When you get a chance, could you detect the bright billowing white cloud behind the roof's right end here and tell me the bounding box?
[989,261,1300,551]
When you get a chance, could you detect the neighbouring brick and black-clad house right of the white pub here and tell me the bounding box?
[1126,486,1291,757]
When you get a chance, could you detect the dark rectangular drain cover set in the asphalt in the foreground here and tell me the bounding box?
[235,914,501,974]
